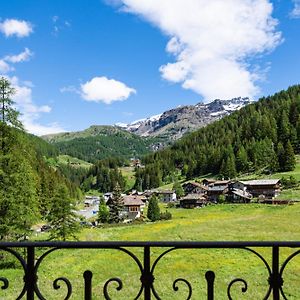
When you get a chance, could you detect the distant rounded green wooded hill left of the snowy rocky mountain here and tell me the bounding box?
[43,126,155,163]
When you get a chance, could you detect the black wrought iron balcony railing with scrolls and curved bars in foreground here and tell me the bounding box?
[0,242,300,300]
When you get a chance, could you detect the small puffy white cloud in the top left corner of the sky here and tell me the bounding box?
[0,19,33,37]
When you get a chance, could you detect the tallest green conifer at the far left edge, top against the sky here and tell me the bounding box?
[0,77,38,240]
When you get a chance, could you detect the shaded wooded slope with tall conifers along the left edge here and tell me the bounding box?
[0,78,81,240]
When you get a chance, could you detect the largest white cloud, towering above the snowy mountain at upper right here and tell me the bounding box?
[110,0,282,100]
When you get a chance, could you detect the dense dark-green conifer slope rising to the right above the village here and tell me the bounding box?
[136,85,300,189]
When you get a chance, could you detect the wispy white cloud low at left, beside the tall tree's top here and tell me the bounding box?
[3,76,65,135]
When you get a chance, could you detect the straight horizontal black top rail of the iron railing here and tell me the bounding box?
[0,241,300,249]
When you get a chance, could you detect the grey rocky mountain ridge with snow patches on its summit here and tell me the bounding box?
[116,97,253,141]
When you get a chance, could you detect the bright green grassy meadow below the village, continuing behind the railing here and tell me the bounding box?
[0,204,300,299]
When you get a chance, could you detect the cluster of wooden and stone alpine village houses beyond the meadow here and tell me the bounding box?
[77,179,288,222]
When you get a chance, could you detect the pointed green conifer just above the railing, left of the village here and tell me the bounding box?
[47,184,79,241]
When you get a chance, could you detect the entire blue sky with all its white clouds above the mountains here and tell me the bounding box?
[0,0,300,135]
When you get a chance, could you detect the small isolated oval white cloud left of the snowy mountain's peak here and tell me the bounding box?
[81,76,136,104]
